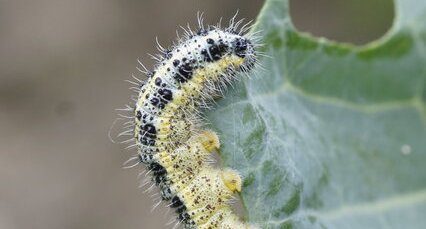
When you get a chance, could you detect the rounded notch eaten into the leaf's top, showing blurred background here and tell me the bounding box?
[290,0,394,45]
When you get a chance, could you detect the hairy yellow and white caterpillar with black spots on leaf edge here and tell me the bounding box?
[122,14,258,229]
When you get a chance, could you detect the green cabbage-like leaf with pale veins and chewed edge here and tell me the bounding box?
[208,0,426,229]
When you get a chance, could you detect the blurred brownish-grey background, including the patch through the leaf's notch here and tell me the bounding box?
[0,0,393,229]
